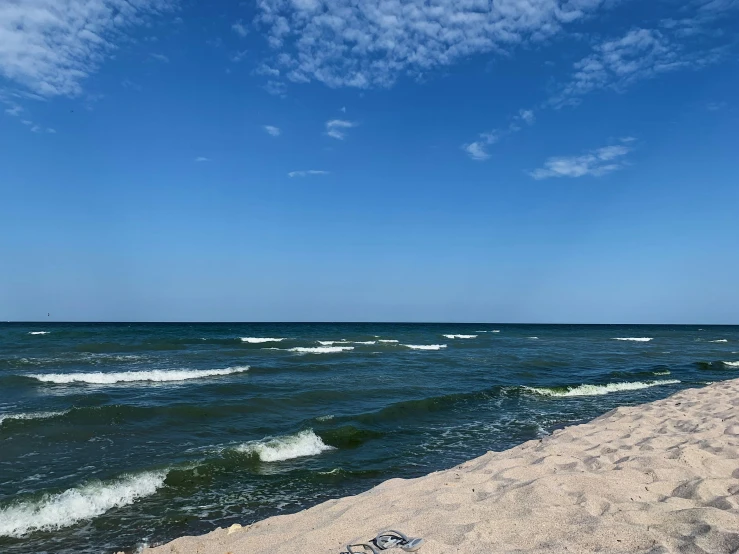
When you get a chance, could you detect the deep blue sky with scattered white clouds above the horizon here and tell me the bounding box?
[0,0,739,323]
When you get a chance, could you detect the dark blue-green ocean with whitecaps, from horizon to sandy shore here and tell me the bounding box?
[0,323,739,554]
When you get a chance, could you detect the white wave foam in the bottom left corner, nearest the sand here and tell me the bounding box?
[0,471,167,537]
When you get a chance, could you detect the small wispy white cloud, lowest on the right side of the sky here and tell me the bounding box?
[530,137,634,179]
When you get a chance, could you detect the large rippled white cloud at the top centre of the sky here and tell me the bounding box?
[257,0,612,88]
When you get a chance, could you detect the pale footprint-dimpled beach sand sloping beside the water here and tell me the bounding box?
[144,379,739,554]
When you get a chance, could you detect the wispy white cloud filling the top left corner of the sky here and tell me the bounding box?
[0,0,174,97]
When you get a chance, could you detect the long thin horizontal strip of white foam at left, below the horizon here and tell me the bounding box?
[28,366,249,385]
